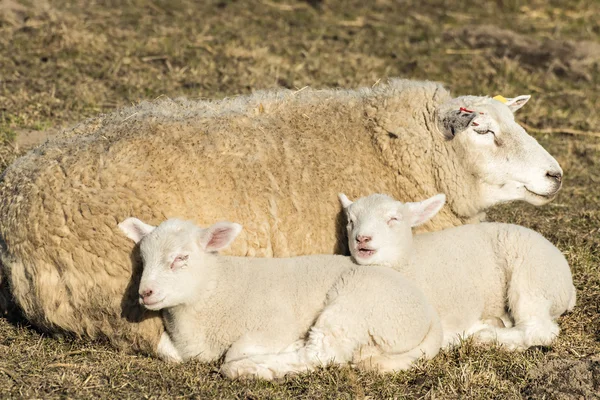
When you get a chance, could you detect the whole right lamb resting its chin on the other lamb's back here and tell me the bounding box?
[339,194,576,350]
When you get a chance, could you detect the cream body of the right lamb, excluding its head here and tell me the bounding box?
[410,223,576,348]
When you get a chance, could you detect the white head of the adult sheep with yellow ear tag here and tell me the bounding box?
[438,96,562,215]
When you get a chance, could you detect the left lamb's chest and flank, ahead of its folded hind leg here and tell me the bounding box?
[163,256,354,362]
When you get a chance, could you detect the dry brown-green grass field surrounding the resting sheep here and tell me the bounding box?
[0,0,600,399]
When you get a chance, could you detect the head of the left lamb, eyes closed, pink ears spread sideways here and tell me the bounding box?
[119,218,242,310]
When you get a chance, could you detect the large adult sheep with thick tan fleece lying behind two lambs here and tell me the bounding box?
[0,80,562,352]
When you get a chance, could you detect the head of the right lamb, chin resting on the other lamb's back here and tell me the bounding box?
[339,194,446,266]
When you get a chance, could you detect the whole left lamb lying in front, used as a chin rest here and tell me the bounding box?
[119,217,442,380]
